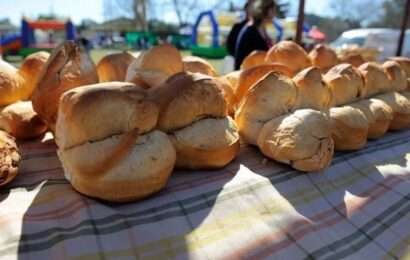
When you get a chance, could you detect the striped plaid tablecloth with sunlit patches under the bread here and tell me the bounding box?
[0,131,410,259]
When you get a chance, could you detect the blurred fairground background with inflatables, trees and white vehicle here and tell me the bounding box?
[0,0,410,71]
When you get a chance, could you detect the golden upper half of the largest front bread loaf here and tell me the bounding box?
[55,82,158,149]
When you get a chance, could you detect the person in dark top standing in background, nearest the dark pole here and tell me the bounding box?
[234,0,276,70]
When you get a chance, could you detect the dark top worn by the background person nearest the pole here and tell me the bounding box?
[235,25,269,70]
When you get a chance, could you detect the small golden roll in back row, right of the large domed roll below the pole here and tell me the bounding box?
[309,44,339,73]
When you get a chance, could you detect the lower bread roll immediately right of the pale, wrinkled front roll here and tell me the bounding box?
[329,106,369,151]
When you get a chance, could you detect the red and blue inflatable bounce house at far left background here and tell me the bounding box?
[0,18,76,57]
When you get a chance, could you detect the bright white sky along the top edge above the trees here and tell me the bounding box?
[0,0,331,25]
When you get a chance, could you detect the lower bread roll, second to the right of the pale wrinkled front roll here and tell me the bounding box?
[351,98,393,139]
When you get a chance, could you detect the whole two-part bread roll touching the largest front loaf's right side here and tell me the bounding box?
[150,73,239,169]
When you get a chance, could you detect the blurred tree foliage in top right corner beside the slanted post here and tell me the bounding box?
[369,0,410,28]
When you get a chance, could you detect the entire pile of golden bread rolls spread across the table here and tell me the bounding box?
[0,41,410,201]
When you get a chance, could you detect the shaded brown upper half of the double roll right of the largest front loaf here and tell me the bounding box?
[149,73,228,132]
